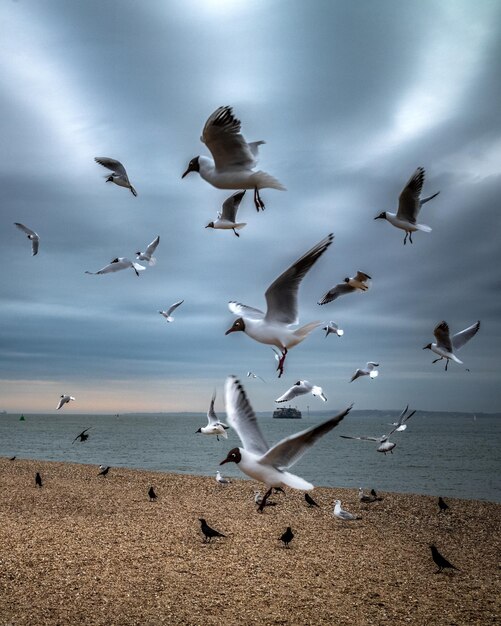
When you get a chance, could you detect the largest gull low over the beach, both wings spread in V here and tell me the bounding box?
[220,376,351,511]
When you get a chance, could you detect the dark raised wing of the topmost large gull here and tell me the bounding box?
[200,106,256,170]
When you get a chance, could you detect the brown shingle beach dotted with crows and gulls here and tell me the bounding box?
[0,458,501,626]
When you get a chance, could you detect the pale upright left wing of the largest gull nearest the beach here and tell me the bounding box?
[224,376,269,456]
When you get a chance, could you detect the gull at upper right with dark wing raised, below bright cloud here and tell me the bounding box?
[374,167,440,245]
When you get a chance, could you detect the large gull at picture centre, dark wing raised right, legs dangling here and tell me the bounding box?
[225,233,334,378]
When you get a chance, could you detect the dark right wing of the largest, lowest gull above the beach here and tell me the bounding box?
[261,404,353,469]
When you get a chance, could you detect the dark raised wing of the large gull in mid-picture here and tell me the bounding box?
[265,233,334,324]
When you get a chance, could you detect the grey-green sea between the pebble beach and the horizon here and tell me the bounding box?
[0,411,501,502]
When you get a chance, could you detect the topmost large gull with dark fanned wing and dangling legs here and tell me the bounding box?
[182,106,285,211]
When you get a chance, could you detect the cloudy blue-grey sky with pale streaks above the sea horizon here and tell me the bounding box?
[0,0,501,413]
